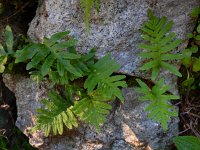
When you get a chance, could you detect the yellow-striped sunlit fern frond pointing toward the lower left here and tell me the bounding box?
[32,92,78,136]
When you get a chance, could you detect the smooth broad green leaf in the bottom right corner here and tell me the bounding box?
[173,136,200,150]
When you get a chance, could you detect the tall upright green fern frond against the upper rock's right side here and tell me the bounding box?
[139,10,182,80]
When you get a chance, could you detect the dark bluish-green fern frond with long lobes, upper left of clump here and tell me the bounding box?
[15,32,87,84]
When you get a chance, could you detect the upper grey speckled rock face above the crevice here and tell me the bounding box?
[28,0,200,94]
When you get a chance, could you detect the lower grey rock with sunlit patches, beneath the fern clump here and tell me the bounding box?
[3,74,179,150]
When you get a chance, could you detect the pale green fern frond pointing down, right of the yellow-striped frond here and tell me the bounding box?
[73,92,112,131]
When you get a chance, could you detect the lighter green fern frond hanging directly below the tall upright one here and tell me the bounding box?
[137,79,179,131]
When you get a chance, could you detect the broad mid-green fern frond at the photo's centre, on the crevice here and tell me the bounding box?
[84,54,127,101]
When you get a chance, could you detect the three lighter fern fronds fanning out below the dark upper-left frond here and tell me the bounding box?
[33,51,127,136]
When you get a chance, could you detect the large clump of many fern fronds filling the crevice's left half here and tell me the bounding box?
[1,24,127,136]
